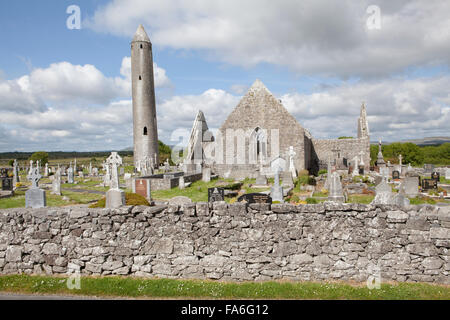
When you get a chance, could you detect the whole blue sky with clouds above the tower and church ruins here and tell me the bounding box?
[0,0,450,152]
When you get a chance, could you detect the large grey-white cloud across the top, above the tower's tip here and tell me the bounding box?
[85,0,450,77]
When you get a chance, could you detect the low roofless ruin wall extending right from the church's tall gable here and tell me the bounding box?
[312,138,370,170]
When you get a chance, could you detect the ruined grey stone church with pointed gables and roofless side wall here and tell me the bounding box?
[185,80,370,178]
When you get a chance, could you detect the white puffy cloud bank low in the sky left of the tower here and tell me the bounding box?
[0,57,171,151]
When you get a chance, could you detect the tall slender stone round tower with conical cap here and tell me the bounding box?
[131,25,159,171]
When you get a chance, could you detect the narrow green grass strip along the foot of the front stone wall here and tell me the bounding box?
[0,275,450,300]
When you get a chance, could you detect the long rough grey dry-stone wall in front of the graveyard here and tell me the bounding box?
[0,202,450,284]
